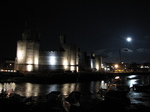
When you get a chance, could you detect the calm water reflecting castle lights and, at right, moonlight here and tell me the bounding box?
[0,75,150,106]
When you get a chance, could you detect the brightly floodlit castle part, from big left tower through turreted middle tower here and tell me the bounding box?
[16,32,86,72]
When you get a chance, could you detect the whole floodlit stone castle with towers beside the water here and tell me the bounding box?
[15,29,102,72]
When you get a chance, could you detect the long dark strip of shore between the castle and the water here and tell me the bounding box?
[0,72,150,83]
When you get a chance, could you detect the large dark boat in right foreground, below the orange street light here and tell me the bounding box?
[98,77,131,106]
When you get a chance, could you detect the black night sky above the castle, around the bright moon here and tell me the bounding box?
[0,0,150,63]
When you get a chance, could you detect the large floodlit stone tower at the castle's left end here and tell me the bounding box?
[15,26,39,71]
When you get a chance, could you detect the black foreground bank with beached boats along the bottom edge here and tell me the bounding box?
[0,91,150,112]
